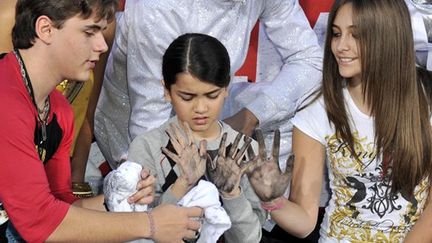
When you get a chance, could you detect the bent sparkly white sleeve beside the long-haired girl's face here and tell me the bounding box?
[235,0,322,126]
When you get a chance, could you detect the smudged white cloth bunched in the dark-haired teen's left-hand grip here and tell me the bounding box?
[104,161,147,212]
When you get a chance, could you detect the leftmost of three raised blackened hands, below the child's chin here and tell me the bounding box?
[162,122,207,189]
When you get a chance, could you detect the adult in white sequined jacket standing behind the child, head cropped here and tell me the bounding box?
[95,0,322,168]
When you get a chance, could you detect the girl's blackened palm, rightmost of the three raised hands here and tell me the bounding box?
[246,129,294,202]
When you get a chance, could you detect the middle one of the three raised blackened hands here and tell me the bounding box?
[207,133,252,197]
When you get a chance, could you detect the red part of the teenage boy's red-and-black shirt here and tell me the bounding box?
[0,53,76,242]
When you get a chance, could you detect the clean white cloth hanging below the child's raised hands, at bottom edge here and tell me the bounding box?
[178,180,231,243]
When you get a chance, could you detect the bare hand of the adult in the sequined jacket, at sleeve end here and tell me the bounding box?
[224,108,258,137]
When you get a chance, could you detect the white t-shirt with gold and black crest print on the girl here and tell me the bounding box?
[292,89,428,242]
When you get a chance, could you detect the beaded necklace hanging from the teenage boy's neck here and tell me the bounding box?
[14,49,51,141]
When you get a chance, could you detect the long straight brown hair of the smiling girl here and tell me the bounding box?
[321,0,432,195]
